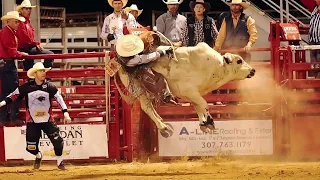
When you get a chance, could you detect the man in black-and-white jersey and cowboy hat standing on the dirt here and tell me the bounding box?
[0,62,71,170]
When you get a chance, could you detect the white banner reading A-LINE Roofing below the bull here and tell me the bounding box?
[158,120,273,156]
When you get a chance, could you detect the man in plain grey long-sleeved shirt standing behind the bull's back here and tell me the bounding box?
[156,0,187,46]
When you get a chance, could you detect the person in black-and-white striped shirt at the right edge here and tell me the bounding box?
[309,0,320,78]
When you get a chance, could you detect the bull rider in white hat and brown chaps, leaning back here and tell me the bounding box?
[116,34,177,105]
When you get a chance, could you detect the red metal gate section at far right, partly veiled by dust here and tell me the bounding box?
[278,45,320,158]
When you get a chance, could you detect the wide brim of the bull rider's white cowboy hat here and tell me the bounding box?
[116,34,144,57]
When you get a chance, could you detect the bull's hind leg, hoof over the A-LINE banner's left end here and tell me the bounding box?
[140,95,173,137]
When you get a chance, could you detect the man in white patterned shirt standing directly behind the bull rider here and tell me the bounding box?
[100,0,137,46]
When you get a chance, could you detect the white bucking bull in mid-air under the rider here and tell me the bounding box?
[114,43,255,133]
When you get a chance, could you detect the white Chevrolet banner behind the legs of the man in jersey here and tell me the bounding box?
[4,124,108,160]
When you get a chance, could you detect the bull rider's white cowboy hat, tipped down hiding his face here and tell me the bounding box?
[116,34,144,57]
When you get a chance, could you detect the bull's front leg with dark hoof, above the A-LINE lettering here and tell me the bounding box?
[185,90,215,132]
